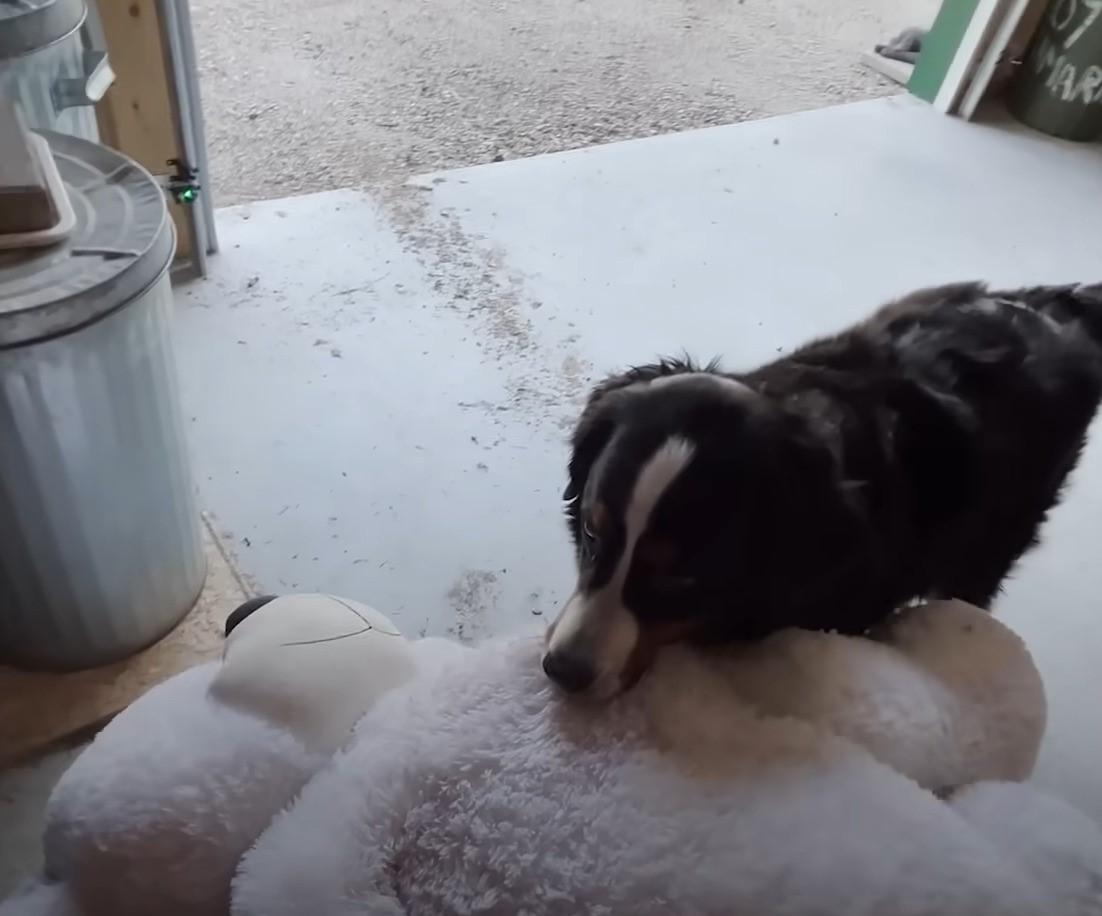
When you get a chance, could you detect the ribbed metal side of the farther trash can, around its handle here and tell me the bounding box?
[0,7,99,141]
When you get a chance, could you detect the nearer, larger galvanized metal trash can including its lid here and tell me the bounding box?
[0,132,206,669]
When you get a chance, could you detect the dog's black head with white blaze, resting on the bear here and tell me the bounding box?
[543,363,861,698]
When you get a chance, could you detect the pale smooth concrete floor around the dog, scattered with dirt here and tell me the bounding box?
[0,98,1102,893]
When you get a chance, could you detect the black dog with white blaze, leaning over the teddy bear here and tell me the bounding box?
[542,282,1102,698]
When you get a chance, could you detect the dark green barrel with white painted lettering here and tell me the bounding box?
[1009,0,1102,141]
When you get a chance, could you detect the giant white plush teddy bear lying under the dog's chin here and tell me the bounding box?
[0,595,1102,916]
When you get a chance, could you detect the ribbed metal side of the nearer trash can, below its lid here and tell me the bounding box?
[0,274,206,668]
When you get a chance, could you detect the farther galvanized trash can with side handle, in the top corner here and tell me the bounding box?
[0,0,115,140]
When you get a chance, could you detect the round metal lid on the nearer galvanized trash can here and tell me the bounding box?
[0,130,175,347]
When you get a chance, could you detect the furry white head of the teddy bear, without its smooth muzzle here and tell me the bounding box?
[27,664,328,916]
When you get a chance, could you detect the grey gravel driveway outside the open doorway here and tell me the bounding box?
[193,0,938,205]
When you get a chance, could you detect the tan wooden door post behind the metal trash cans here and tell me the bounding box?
[96,0,193,261]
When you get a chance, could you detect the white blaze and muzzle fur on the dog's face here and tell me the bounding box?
[548,437,693,677]
